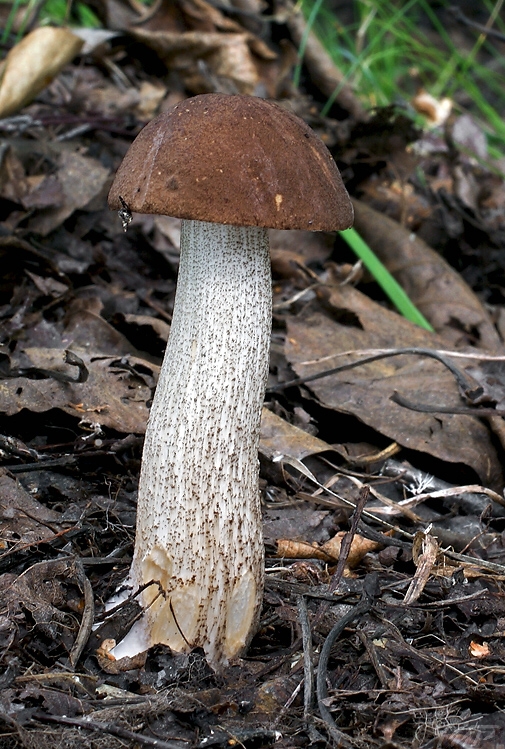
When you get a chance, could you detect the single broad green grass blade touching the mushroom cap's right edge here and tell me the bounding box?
[340,229,434,333]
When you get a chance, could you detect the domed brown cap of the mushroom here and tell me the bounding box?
[109,94,353,231]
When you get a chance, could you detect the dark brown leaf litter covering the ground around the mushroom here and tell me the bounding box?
[0,0,505,749]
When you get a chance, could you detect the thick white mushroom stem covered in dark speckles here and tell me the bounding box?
[115,221,271,666]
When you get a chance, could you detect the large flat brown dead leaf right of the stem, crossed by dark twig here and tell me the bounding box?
[285,286,503,491]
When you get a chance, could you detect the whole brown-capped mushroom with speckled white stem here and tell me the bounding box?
[109,94,353,668]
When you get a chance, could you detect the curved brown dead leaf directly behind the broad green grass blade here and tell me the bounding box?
[353,200,503,351]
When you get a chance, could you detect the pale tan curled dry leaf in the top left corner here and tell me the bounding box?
[0,26,83,117]
